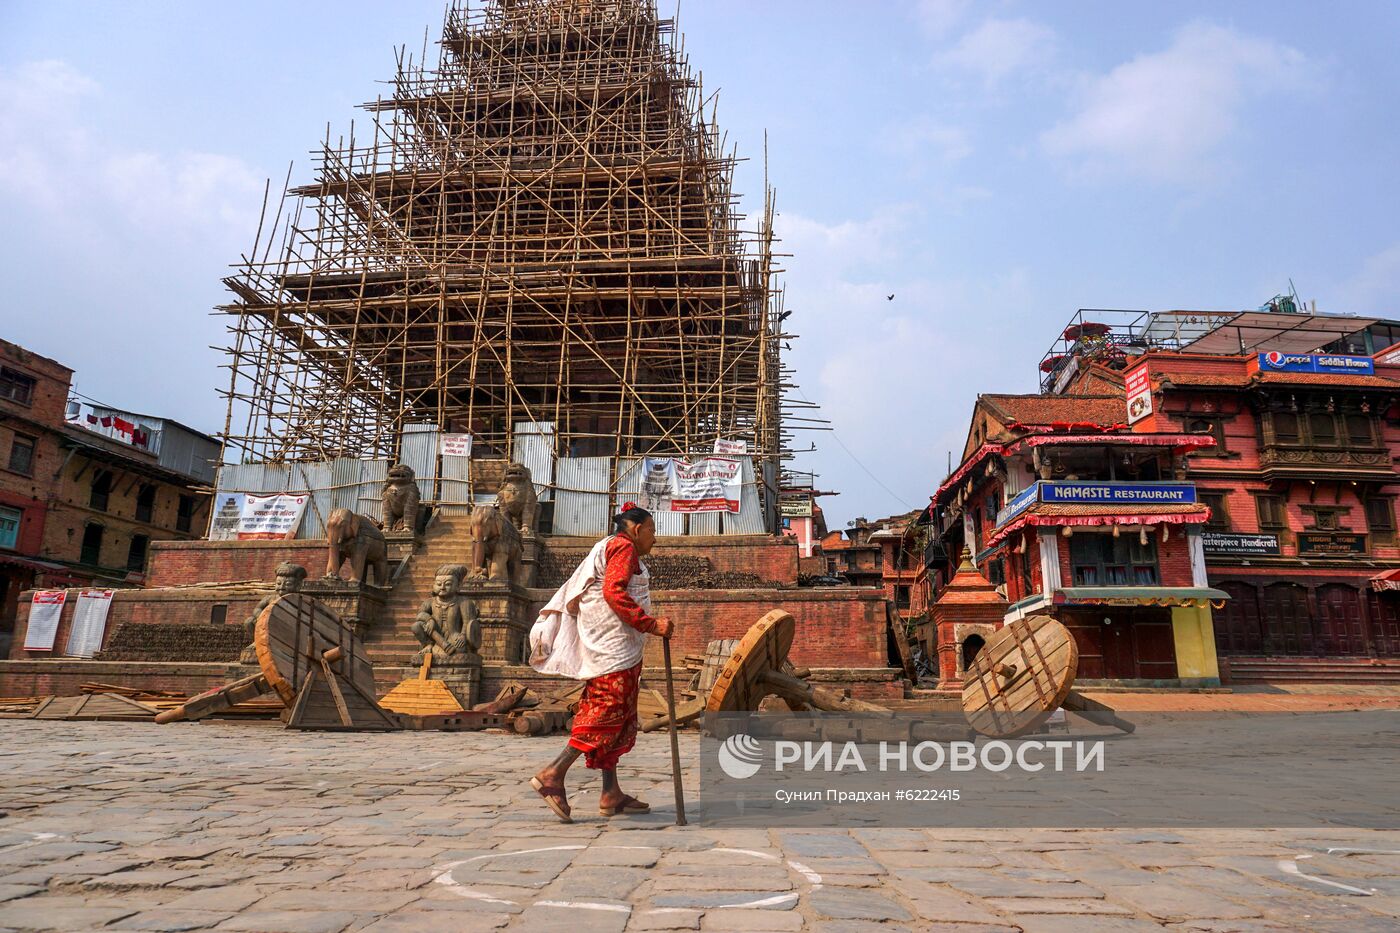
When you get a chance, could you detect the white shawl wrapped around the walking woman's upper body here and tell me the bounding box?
[529,538,651,681]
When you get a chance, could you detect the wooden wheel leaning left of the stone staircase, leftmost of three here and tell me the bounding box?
[253,593,374,706]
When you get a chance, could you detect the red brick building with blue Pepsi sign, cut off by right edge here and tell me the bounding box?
[1123,344,1400,677]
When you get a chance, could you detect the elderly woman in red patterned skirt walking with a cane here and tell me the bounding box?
[529,502,675,822]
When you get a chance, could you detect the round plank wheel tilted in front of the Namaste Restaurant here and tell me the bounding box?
[962,615,1079,738]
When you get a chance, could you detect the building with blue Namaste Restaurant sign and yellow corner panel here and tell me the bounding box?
[925,395,1225,686]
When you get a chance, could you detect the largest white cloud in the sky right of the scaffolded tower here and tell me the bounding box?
[1040,22,1310,182]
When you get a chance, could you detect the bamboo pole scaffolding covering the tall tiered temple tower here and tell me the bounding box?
[218,0,812,479]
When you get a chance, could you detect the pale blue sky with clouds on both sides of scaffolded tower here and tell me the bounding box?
[0,0,1400,527]
